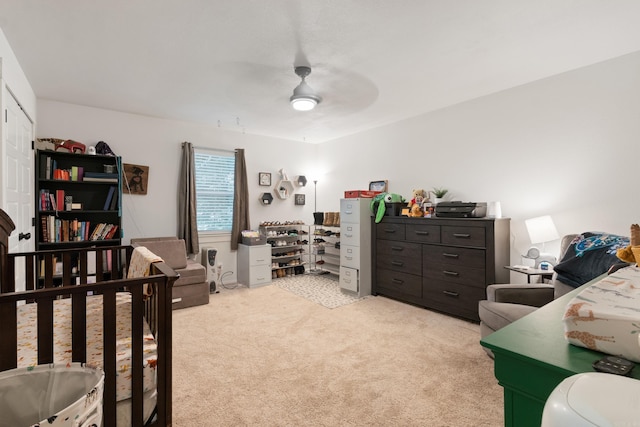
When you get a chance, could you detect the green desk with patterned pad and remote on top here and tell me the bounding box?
[480,276,640,427]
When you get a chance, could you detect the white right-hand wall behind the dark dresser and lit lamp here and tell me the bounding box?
[318,53,640,270]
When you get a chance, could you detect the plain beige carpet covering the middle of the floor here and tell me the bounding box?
[173,279,503,427]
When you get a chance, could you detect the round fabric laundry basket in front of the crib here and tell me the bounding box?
[0,363,104,427]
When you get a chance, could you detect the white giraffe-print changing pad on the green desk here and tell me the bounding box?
[563,266,640,362]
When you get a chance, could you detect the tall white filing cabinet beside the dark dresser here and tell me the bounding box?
[340,198,371,296]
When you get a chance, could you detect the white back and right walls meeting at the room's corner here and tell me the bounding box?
[37,53,640,280]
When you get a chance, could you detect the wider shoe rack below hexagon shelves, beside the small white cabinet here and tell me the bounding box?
[260,220,310,279]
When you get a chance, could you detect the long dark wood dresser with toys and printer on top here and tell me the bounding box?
[372,216,510,322]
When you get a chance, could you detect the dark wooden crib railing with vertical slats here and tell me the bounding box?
[0,246,178,426]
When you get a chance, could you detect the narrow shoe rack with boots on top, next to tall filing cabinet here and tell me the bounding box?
[311,212,340,276]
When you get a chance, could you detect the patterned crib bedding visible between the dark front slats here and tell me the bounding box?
[18,292,157,401]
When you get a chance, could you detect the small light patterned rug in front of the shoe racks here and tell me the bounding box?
[272,274,367,308]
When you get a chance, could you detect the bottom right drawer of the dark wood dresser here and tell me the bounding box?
[422,279,486,321]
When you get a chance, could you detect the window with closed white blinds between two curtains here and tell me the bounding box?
[195,149,235,232]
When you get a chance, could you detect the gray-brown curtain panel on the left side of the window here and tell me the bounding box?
[178,142,200,254]
